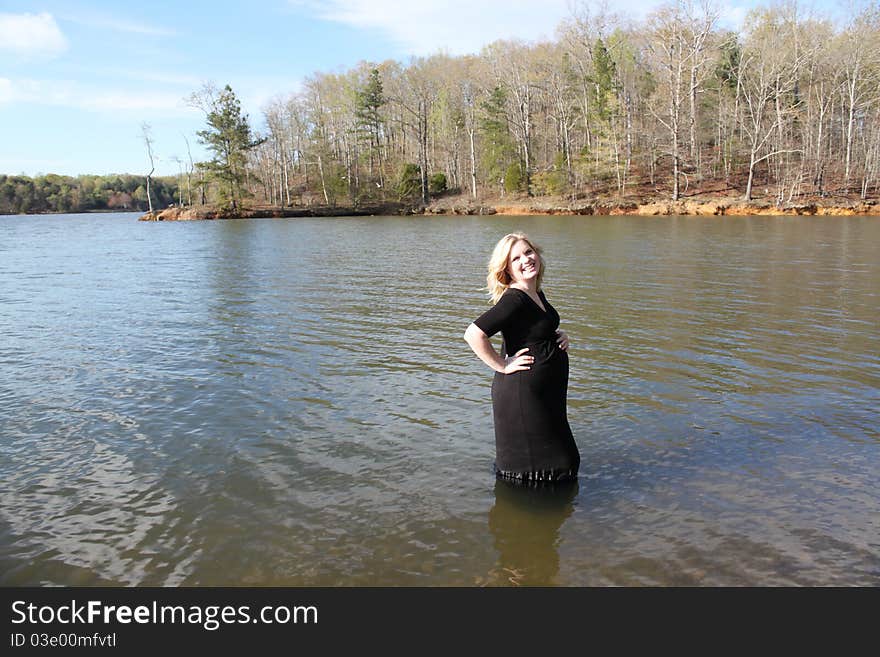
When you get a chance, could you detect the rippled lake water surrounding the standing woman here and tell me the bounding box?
[0,214,880,586]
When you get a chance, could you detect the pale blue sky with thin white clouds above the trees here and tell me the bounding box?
[0,0,852,176]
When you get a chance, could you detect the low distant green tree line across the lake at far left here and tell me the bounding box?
[0,174,178,214]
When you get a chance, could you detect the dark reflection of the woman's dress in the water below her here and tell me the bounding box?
[487,479,579,586]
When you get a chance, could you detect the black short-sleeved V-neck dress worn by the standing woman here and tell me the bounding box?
[474,288,580,481]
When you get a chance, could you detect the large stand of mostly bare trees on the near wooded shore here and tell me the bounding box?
[196,0,880,205]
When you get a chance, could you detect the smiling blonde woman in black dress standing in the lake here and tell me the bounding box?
[464,233,580,482]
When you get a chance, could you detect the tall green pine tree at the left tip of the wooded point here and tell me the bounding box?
[196,84,265,210]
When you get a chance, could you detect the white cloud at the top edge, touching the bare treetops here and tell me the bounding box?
[293,0,570,55]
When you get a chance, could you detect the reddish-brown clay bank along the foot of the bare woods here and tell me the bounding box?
[140,195,880,221]
